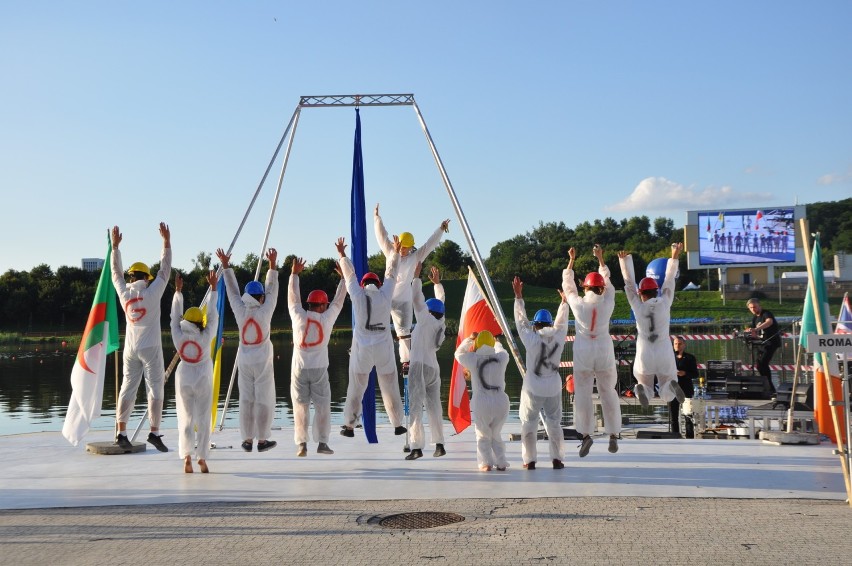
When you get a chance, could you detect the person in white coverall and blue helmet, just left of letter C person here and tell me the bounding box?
[405,263,447,460]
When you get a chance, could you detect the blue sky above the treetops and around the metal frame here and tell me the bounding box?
[0,0,852,272]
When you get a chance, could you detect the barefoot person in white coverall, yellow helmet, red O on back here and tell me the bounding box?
[171,270,219,474]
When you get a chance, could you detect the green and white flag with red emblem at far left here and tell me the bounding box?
[62,233,119,446]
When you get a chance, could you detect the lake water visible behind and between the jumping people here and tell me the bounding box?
[0,336,659,435]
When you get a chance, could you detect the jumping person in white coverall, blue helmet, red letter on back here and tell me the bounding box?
[216,248,278,452]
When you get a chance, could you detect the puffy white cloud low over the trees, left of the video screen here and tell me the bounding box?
[606,177,771,212]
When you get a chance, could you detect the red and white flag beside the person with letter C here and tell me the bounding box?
[447,267,503,433]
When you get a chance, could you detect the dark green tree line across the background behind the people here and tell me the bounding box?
[0,198,852,333]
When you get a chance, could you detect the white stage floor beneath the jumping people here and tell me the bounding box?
[0,424,846,509]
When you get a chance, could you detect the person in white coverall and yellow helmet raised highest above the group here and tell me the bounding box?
[373,204,450,372]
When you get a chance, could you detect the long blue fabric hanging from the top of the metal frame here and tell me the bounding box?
[350,108,379,444]
